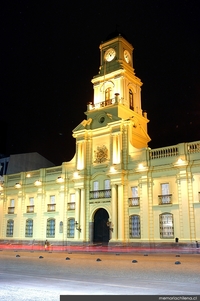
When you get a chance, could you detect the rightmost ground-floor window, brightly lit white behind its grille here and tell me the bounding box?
[160,213,174,238]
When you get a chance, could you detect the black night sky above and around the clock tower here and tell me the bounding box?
[0,0,200,165]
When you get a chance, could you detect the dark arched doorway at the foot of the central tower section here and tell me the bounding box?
[93,208,110,245]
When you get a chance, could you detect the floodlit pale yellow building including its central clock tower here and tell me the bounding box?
[0,35,200,245]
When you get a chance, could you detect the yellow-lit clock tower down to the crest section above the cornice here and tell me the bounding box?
[73,34,150,169]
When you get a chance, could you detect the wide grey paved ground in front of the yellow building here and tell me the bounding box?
[0,249,200,301]
